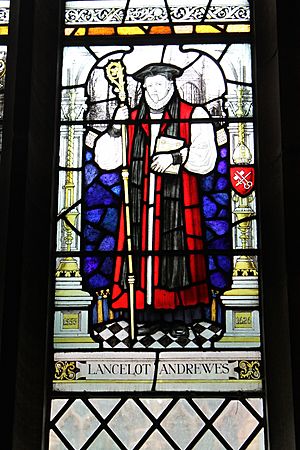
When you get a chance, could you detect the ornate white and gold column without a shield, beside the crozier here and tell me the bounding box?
[54,82,99,349]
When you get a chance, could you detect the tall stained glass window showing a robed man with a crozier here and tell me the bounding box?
[49,0,266,449]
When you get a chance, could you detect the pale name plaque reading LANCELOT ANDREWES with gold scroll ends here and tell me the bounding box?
[54,351,261,391]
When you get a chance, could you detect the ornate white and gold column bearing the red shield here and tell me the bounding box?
[216,81,260,348]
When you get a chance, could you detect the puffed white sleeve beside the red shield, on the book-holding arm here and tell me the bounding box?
[184,106,217,174]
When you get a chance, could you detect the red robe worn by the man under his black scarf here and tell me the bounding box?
[112,100,209,310]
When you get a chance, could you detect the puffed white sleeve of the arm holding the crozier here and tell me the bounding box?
[95,128,122,170]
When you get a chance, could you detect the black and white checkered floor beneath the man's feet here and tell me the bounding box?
[94,320,222,350]
